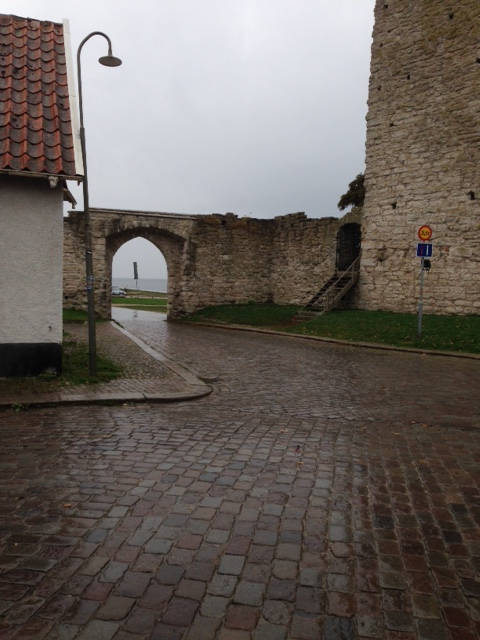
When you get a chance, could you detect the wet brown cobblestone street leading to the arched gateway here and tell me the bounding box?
[0,312,480,640]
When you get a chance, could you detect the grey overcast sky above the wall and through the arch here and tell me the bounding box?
[8,0,374,277]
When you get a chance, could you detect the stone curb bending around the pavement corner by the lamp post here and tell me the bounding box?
[0,321,213,410]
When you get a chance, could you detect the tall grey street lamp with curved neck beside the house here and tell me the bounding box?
[77,31,122,377]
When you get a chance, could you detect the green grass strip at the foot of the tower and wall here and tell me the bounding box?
[187,303,480,353]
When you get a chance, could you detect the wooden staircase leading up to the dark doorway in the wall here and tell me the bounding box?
[295,257,360,322]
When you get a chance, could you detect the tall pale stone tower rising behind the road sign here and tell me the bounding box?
[357,0,480,314]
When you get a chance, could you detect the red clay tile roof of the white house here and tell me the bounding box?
[0,14,77,182]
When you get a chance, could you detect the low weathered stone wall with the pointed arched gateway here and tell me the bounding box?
[64,209,359,318]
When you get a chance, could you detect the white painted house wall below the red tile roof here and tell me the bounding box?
[0,176,63,344]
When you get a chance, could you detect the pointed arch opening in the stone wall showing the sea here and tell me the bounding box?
[111,237,168,313]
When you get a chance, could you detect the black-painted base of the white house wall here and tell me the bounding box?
[0,342,62,377]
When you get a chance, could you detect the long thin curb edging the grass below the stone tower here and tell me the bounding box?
[182,320,480,360]
